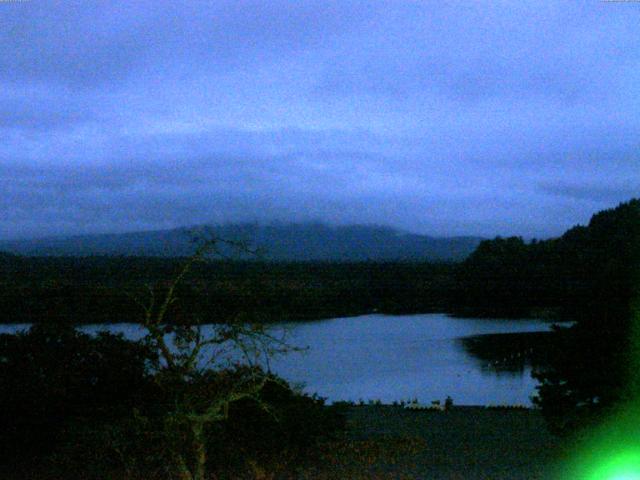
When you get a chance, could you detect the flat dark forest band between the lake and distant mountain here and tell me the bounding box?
[0,256,453,323]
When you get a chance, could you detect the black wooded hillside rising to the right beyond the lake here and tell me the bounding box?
[455,199,640,324]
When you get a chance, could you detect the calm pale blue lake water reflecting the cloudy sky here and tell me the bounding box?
[0,314,564,405]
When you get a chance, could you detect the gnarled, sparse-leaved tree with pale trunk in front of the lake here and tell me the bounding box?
[132,232,294,480]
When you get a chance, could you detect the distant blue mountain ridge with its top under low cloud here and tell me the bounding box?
[0,223,482,261]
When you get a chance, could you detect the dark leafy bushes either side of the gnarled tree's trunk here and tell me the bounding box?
[0,324,344,479]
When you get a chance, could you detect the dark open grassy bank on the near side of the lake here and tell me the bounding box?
[300,406,562,480]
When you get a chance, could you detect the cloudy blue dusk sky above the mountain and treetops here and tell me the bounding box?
[0,0,640,239]
